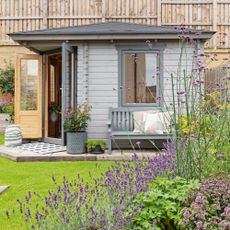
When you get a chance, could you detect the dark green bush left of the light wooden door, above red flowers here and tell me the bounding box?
[0,63,14,95]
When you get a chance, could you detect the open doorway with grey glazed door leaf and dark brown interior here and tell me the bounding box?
[44,43,76,145]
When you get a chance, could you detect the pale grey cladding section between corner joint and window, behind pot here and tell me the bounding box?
[88,42,119,139]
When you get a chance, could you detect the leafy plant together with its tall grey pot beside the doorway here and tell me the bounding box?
[64,104,91,154]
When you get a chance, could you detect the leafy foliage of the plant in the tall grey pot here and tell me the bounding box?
[64,105,91,132]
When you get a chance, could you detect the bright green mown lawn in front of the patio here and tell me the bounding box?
[0,134,111,230]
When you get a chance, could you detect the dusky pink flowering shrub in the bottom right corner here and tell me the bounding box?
[180,176,230,230]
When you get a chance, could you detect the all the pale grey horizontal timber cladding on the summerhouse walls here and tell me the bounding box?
[78,41,199,139]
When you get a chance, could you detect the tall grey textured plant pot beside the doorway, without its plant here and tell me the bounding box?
[66,132,87,154]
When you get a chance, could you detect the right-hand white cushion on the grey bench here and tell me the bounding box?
[144,112,172,134]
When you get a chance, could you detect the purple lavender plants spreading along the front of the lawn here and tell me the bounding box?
[7,143,175,229]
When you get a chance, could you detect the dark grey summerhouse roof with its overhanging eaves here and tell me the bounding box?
[8,23,215,52]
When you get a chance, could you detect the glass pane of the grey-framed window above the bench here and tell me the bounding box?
[122,51,160,106]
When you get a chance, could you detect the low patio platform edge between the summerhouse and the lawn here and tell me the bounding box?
[0,145,159,162]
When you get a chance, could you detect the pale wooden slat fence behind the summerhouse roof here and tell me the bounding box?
[0,0,230,48]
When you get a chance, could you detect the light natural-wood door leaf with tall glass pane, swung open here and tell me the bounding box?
[15,55,42,138]
